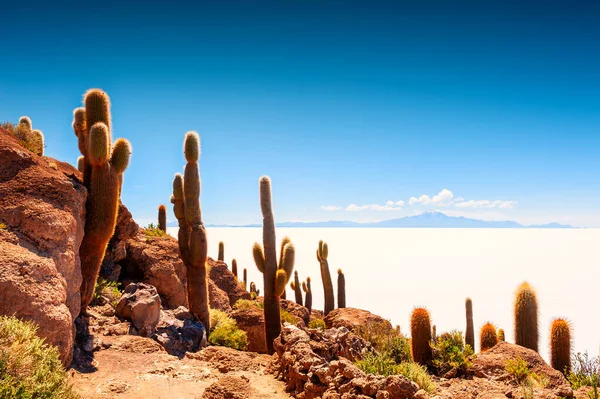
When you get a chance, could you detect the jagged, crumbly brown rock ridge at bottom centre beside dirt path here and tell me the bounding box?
[275,326,419,399]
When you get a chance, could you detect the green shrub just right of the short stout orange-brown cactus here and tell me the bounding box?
[431,330,473,375]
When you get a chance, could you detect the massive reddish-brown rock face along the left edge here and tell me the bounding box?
[0,131,86,364]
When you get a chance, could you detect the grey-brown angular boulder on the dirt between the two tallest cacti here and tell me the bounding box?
[115,283,160,337]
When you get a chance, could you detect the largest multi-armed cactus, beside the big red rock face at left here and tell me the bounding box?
[74,89,131,312]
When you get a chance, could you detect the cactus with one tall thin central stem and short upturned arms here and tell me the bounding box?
[252,176,295,354]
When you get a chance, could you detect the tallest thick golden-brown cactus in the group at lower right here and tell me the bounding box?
[514,282,539,352]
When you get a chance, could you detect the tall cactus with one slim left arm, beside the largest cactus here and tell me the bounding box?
[171,132,210,331]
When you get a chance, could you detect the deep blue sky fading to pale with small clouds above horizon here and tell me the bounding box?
[0,0,600,227]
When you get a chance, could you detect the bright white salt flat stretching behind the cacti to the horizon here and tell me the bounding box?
[168,227,600,360]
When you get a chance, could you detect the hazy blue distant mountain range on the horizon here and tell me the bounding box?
[190,212,574,229]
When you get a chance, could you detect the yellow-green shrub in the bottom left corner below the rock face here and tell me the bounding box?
[0,316,79,399]
